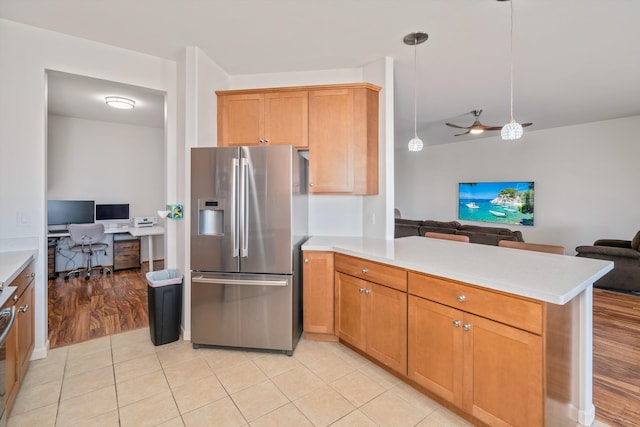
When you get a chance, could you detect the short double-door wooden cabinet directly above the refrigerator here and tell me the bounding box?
[216,89,309,150]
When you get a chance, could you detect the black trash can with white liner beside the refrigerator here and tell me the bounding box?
[146,269,182,345]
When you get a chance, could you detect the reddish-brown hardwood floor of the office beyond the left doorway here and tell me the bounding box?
[48,261,164,348]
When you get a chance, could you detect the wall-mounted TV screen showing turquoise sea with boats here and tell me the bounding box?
[458,181,534,225]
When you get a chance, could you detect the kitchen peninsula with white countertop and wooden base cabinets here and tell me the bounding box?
[302,236,613,426]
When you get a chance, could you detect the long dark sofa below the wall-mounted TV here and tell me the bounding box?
[395,218,524,246]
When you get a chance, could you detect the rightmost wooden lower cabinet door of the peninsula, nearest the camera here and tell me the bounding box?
[463,313,544,426]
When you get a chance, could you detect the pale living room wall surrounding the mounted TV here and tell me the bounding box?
[395,116,640,254]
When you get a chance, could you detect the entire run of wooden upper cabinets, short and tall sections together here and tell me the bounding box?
[216,83,381,195]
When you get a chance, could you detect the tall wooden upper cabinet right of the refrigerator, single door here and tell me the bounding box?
[309,83,380,194]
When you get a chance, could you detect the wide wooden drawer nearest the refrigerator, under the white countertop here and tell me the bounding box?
[334,254,407,292]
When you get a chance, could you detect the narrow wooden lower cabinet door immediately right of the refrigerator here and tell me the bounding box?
[302,251,335,335]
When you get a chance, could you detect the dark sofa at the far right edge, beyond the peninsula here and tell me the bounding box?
[576,231,640,293]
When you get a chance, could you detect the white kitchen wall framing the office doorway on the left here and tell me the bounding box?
[0,19,177,358]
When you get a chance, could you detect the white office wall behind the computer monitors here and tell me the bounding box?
[47,114,165,260]
